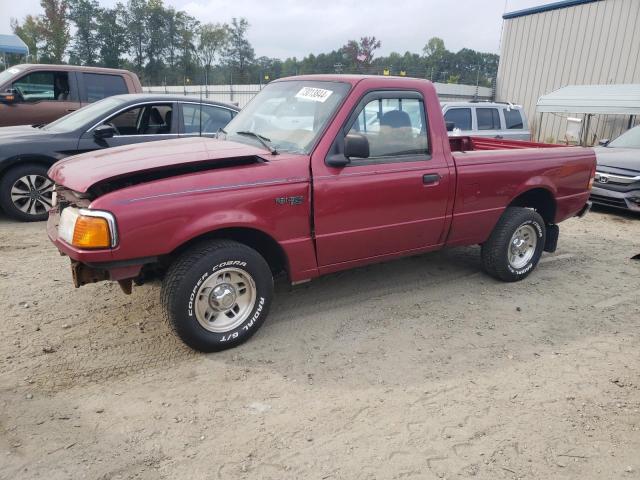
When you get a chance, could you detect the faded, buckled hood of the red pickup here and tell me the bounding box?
[49,137,265,192]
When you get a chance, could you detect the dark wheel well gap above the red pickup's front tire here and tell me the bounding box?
[170,227,289,275]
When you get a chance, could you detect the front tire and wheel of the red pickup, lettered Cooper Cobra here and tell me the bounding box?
[161,240,273,352]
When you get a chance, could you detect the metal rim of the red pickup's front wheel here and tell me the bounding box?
[195,268,256,333]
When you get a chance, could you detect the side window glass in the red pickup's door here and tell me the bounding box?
[349,98,429,158]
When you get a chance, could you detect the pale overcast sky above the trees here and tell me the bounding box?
[0,0,552,59]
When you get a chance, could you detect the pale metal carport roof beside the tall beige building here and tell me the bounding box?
[537,84,640,115]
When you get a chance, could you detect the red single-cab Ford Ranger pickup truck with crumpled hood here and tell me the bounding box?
[47,75,596,351]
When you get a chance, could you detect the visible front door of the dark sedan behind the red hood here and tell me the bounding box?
[78,102,178,152]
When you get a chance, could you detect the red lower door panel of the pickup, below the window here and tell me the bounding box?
[314,159,450,266]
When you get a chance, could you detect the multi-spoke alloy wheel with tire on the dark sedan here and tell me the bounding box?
[0,164,54,222]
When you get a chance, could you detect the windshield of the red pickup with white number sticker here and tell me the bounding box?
[225,80,349,154]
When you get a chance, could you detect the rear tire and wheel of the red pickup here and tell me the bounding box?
[481,207,546,282]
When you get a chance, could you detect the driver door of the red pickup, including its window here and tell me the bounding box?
[313,91,452,273]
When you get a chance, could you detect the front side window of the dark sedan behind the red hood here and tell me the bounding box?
[104,104,173,135]
